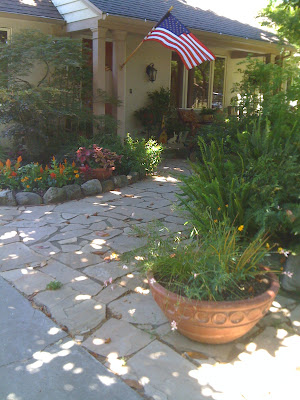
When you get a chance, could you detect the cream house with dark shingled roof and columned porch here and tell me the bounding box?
[0,0,279,136]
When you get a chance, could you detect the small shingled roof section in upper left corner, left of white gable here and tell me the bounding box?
[0,0,63,20]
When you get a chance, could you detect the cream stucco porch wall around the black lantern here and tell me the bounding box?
[125,34,171,132]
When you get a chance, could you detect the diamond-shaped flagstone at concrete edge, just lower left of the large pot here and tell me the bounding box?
[83,318,153,357]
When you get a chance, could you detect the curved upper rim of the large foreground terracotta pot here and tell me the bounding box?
[147,267,280,309]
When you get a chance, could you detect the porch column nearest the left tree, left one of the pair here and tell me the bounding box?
[91,27,107,115]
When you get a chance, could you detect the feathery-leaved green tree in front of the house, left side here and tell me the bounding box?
[0,30,93,161]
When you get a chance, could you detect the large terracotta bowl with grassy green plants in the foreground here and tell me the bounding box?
[135,216,279,343]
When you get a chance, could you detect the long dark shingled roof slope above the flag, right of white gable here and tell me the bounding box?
[89,0,278,42]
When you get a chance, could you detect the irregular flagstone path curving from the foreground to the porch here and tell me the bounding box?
[0,161,300,400]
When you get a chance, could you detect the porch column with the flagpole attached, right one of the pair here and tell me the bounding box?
[112,30,127,138]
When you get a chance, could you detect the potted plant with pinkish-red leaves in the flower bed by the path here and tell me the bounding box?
[76,144,122,180]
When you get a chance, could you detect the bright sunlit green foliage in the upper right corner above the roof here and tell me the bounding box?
[260,0,300,47]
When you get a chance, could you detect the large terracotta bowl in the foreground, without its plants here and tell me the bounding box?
[148,273,279,344]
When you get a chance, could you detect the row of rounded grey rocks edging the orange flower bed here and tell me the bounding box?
[0,172,145,206]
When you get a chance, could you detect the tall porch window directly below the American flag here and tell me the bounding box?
[171,53,226,109]
